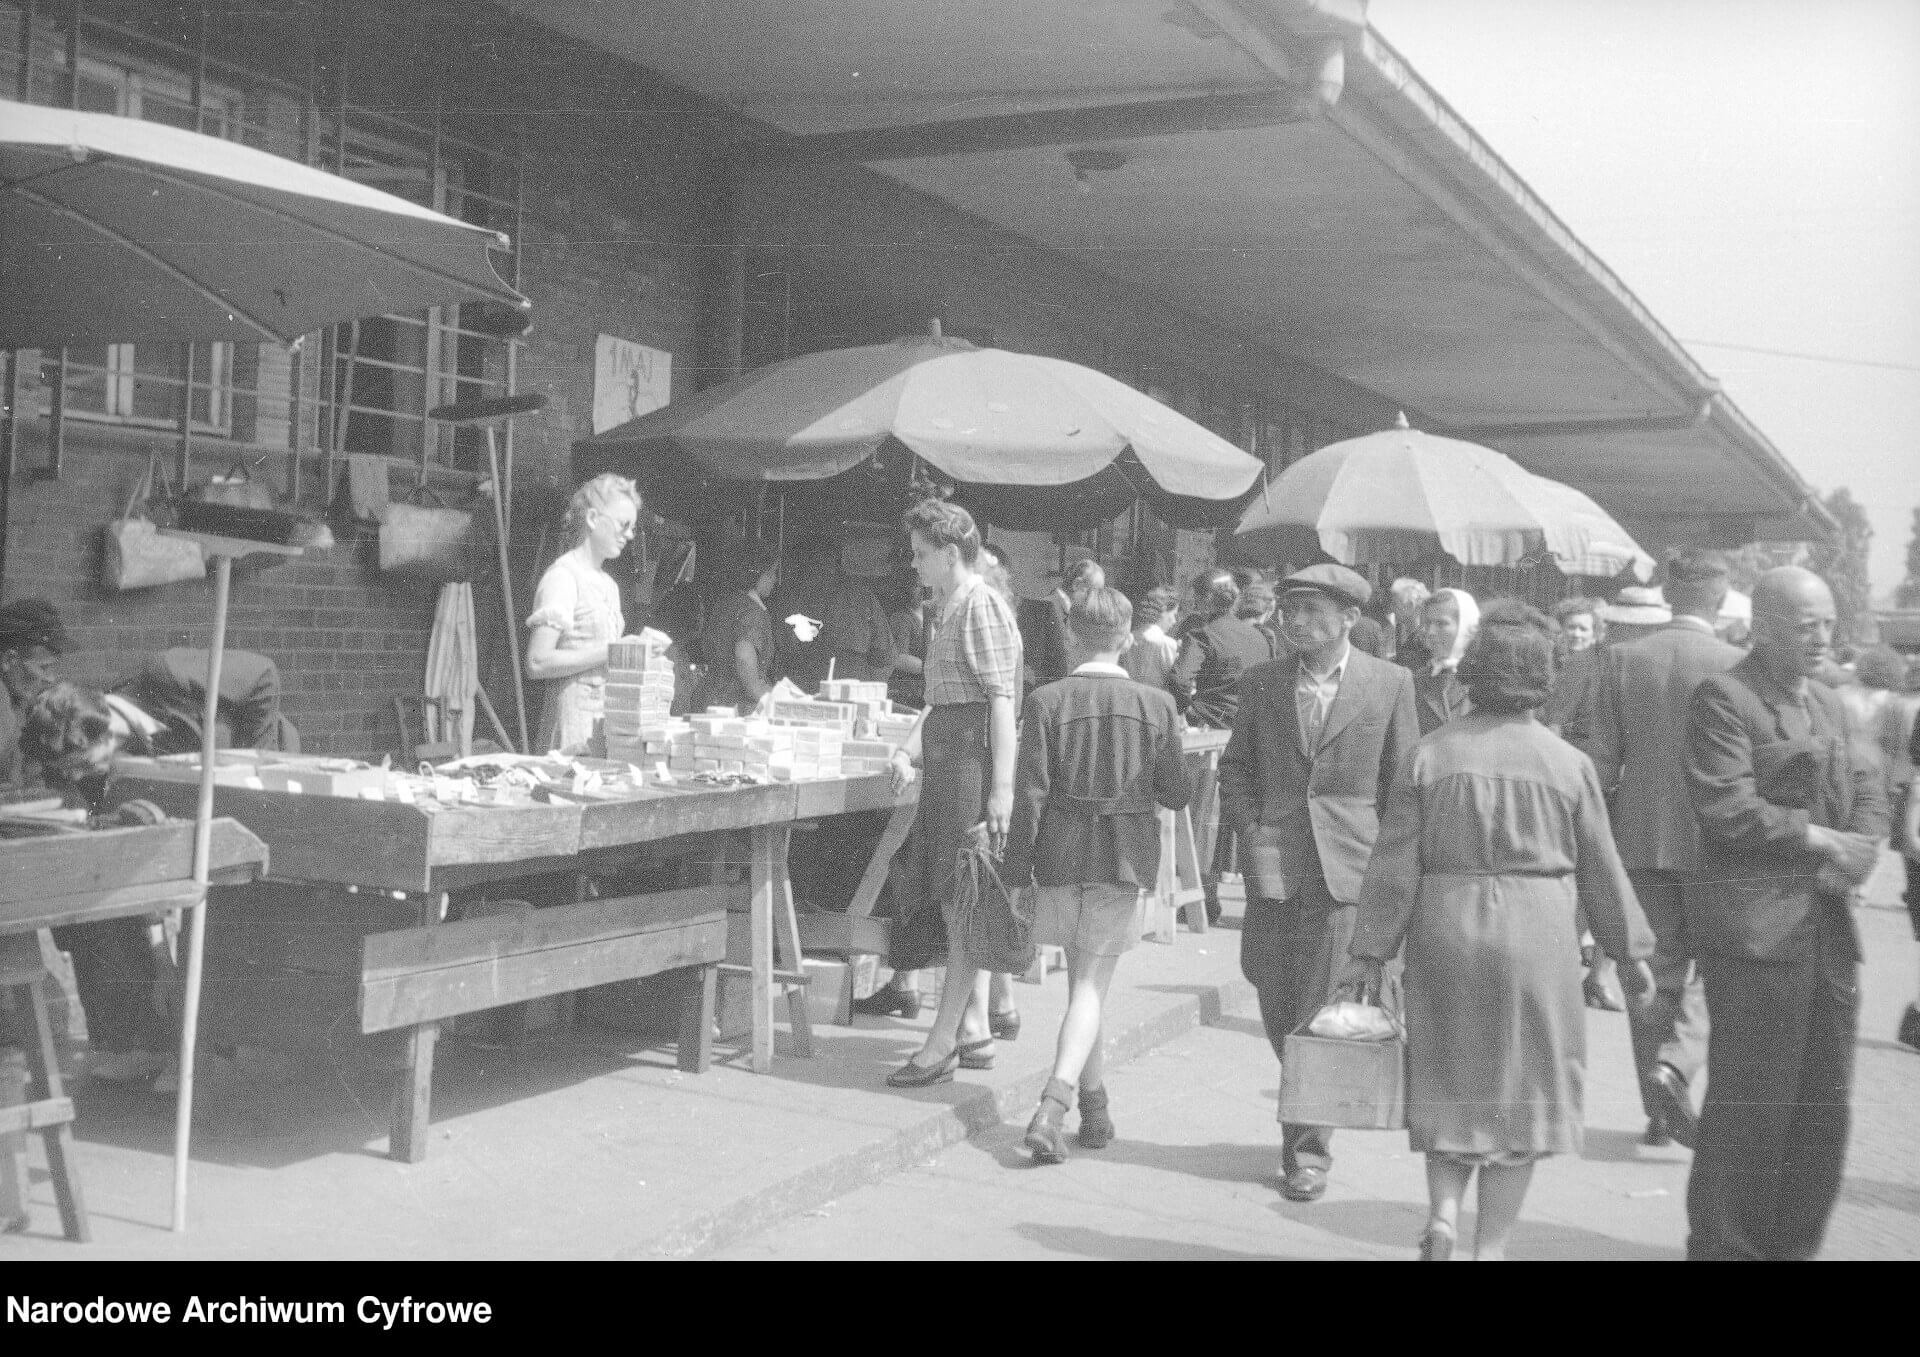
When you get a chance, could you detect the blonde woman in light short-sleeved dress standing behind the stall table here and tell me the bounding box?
[526,472,641,754]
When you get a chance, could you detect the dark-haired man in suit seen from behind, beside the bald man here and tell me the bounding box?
[1589,551,1741,1146]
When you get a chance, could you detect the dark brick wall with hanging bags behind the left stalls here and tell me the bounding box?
[0,4,729,756]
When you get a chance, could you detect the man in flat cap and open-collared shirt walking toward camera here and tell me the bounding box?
[1219,566,1419,1202]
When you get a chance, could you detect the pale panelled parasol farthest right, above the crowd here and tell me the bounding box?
[1235,415,1653,578]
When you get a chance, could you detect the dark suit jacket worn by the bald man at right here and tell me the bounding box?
[1684,656,1887,962]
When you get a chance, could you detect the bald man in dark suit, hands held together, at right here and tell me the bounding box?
[1684,566,1887,1259]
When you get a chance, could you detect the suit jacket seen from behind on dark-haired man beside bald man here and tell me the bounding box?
[1586,622,1741,871]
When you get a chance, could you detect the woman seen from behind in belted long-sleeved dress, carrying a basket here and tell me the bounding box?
[1336,601,1653,1261]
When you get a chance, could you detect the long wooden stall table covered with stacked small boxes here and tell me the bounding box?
[115,770,912,1161]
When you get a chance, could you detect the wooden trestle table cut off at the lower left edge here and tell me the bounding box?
[0,817,267,1242]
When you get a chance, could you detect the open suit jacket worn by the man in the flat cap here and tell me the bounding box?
[1219,651,1421,902]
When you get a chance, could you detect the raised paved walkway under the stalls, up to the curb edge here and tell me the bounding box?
[0,890,1242,1261]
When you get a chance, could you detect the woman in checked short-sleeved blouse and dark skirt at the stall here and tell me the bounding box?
[887,499,1020,1088]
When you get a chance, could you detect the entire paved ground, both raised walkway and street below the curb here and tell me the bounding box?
[0,863,1920,1261]
